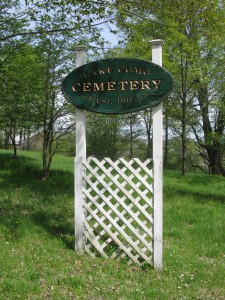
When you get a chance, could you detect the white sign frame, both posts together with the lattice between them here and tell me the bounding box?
[74,40,163,271]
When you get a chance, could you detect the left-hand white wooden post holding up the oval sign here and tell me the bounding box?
[74,46,86,253]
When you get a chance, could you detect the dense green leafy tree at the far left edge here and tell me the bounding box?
[0,44,41,158]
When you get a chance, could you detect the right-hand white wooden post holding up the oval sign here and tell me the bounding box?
[150,40,163,271]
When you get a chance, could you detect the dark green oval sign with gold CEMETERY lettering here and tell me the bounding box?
[62,58,173,114]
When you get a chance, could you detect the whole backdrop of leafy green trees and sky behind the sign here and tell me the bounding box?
[0,0,225,178]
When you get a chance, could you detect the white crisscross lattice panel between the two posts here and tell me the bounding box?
[82,158,153,265]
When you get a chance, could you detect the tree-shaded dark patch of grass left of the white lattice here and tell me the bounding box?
[0,152,74,249]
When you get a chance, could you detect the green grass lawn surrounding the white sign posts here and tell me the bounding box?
[0,151,225,300]
